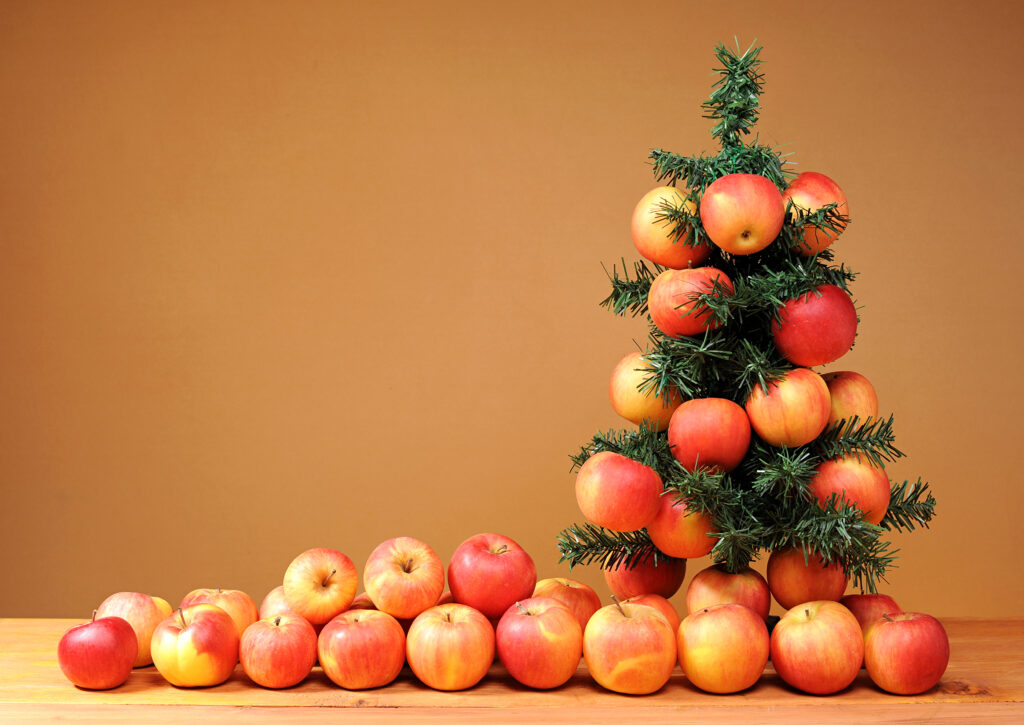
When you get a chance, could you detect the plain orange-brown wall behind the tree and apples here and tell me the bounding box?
[0,0,1024,616]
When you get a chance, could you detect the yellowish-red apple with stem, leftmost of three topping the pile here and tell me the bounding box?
[285,548,359,626]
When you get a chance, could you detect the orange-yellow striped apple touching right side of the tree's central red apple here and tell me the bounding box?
[745,368,830,447]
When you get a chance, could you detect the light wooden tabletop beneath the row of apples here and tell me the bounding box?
[0,619,1024,725]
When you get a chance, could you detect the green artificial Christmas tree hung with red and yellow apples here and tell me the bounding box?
[558,40,935,601]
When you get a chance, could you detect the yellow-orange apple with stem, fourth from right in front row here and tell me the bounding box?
[583,603,676,694]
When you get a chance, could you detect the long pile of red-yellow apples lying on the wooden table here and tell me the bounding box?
[57,534,948,694]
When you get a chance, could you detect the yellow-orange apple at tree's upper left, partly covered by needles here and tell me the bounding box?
[631,186,712,269]
